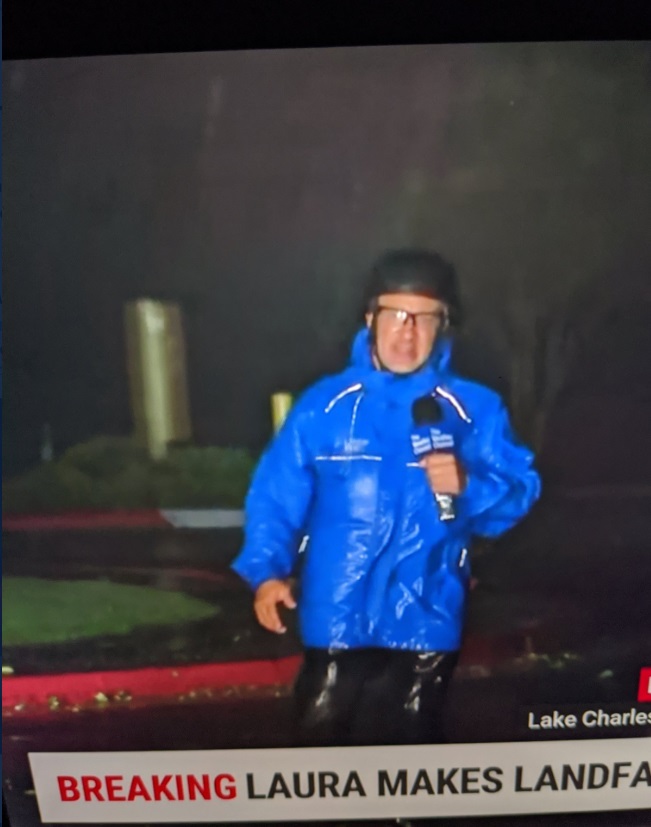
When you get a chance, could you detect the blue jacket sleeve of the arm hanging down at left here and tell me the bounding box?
[231,401,314,590]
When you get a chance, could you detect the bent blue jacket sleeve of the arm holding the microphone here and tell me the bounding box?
[459,396,540,537]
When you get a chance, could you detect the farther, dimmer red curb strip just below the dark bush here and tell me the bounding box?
[2,508,170,531]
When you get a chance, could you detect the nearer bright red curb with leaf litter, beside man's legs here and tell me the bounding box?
[2,655,302,709]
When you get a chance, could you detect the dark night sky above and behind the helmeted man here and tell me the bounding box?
[2,43,651,482]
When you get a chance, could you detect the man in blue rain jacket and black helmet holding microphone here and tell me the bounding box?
[233,250,540,745]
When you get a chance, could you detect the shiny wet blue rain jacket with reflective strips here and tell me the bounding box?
[233,330,540,651]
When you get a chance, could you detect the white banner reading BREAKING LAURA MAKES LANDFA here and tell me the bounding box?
[29,738,651,824]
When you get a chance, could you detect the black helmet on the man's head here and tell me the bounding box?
[366,249,461,326]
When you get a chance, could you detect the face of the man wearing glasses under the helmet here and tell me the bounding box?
[366,293,445,373]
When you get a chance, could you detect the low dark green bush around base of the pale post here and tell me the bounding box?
[2,437,255,514]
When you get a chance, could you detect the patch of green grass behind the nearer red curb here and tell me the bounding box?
[2,577,219,646]
